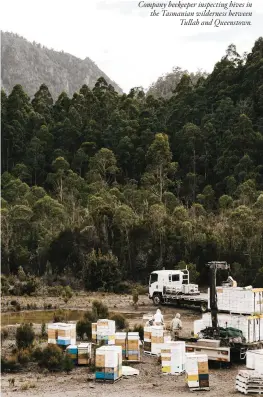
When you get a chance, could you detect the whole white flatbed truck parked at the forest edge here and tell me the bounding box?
[149,269,208,313]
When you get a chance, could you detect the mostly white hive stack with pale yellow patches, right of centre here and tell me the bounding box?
[161,341,185,375]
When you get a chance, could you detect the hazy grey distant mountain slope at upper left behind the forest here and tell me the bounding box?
[1,32,122,98]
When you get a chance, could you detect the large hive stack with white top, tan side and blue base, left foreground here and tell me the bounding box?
[95,346,122,381]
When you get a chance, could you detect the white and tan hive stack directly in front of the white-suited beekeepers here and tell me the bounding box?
[144,325,171,355]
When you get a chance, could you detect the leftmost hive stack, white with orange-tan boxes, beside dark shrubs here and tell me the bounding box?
[48,323,76,346]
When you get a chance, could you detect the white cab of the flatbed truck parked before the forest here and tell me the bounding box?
[149,269,189,305]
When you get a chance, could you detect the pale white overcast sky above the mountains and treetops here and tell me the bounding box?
[0,0,263,92]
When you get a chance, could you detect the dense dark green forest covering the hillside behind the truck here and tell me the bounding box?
[2,38,263,289]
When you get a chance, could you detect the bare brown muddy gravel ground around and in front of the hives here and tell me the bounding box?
[2,294,242,397]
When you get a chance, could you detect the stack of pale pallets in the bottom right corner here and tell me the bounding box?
[236,370,263,394]
